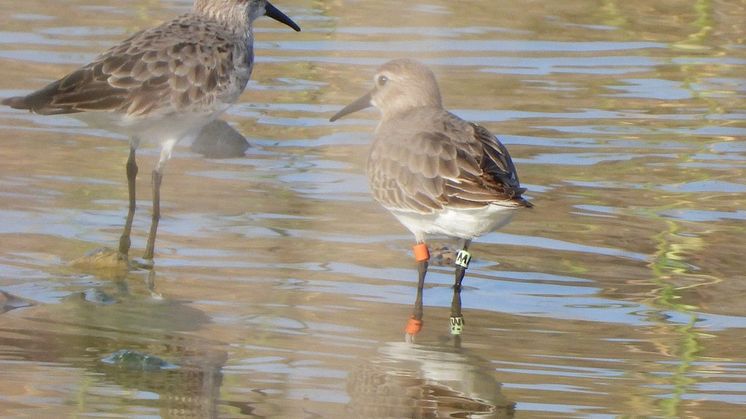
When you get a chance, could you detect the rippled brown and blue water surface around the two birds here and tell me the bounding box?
[0,0,746,418]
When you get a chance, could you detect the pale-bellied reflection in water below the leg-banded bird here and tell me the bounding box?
[347,342,515,418]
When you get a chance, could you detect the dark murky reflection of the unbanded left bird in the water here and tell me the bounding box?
[0,270,227,418]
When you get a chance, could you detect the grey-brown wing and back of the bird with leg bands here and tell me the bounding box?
[368,114,530,213]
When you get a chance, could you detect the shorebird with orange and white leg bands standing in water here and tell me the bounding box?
[330,59,532,337]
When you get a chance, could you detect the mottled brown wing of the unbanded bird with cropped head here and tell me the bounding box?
[4,17,240,116]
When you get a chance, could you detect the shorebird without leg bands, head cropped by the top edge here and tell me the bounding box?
[2,0,300,260]
